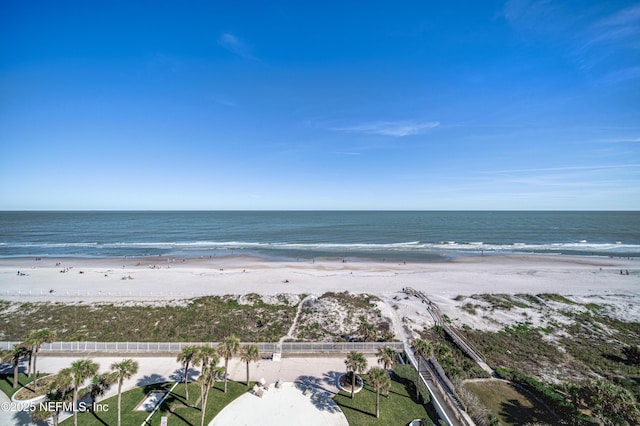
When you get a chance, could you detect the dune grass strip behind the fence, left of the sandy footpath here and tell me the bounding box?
[0,295,296,342]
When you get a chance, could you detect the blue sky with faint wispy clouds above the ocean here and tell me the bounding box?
[0,0,640,210]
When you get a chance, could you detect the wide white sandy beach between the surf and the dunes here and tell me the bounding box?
[0,255,640,303]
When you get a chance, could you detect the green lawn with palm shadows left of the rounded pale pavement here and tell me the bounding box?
[63,382,247,426]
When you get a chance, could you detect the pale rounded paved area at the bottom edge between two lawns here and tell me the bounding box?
[209,380,349,426]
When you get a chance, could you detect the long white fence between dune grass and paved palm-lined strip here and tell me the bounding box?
[0,342,404,354]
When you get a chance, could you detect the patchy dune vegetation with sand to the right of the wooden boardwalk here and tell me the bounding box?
[452,300,640,424]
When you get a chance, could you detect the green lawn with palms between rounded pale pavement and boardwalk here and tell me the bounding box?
[333,375,430,426]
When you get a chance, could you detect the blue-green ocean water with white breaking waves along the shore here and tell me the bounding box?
[0,211,640,260]
